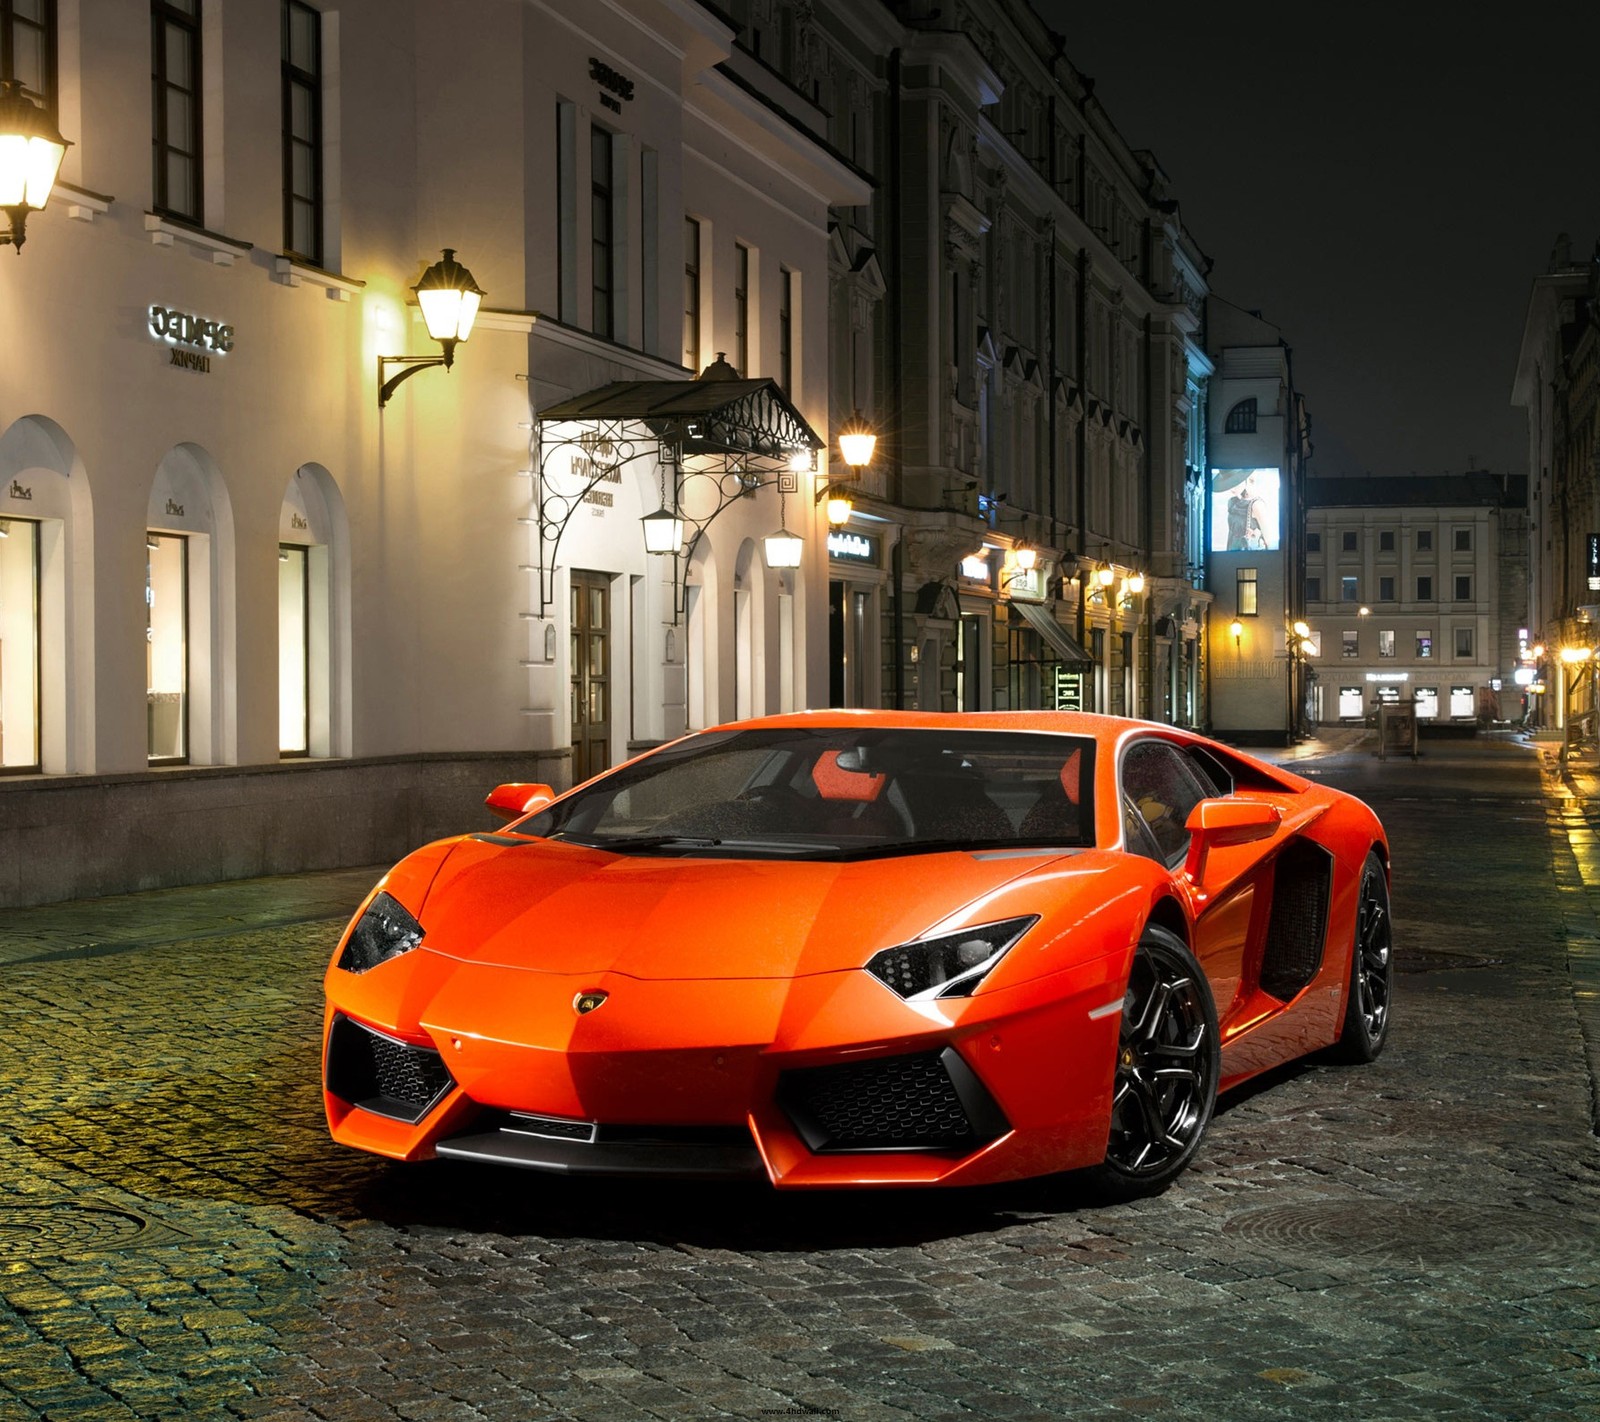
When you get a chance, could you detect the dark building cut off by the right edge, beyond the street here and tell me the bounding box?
[1510,234,1600,726]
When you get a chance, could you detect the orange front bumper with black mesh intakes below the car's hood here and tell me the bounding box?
[323,953,1125,1187]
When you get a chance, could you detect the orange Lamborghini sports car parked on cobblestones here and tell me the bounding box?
[323,712,1392,1196]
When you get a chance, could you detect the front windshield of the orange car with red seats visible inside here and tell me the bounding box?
[515,726,1094,859]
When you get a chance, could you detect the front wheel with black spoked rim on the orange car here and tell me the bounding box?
[1085,925,1222,1200]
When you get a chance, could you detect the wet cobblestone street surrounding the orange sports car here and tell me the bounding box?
[0,739,1600,1422]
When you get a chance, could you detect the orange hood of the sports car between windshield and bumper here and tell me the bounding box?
[418,837,1075,981]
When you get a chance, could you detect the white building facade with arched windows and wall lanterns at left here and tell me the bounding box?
[0,0,867,904]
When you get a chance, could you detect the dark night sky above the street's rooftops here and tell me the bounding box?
[1034,0,1600,475]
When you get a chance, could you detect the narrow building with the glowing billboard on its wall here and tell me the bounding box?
[1205,296,1310,745]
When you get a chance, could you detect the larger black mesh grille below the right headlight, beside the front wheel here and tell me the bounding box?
[779,1048,1005,1152]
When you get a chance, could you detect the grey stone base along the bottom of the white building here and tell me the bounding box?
[0,752,568,907]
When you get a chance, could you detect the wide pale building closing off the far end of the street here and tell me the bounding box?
[1304,473,1528,723]
